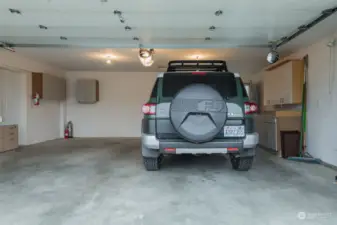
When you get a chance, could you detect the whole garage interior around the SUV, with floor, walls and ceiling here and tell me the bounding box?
[0,0,337,225]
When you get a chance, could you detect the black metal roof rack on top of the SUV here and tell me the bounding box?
[167,60,228,72]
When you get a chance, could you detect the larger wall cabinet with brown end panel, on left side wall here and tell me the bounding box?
[32,73,66,101]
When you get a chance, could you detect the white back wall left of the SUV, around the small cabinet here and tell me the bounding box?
[66,71,157,137]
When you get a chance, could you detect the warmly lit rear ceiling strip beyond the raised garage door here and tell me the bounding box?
[17,48,266,74]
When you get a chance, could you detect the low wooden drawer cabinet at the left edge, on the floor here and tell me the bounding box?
[0,125,19,152]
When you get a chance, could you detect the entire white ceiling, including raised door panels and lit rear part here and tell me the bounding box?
[0,0,337,72]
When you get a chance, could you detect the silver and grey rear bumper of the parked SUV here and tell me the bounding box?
[142,133,259,154]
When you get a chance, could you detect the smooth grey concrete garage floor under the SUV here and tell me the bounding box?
[0,139,337,225]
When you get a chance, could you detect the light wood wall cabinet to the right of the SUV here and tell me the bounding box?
[263,60,304,106]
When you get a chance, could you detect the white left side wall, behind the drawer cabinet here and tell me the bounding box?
[0,51,64,145]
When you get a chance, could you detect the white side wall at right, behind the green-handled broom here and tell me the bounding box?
[256,32,337,166]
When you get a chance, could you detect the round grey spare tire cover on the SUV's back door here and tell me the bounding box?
[170,84,227,143]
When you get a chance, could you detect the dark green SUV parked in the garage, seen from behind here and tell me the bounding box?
[142,61,258,170]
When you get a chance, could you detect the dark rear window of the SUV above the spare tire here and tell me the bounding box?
[162,73,237,98]
